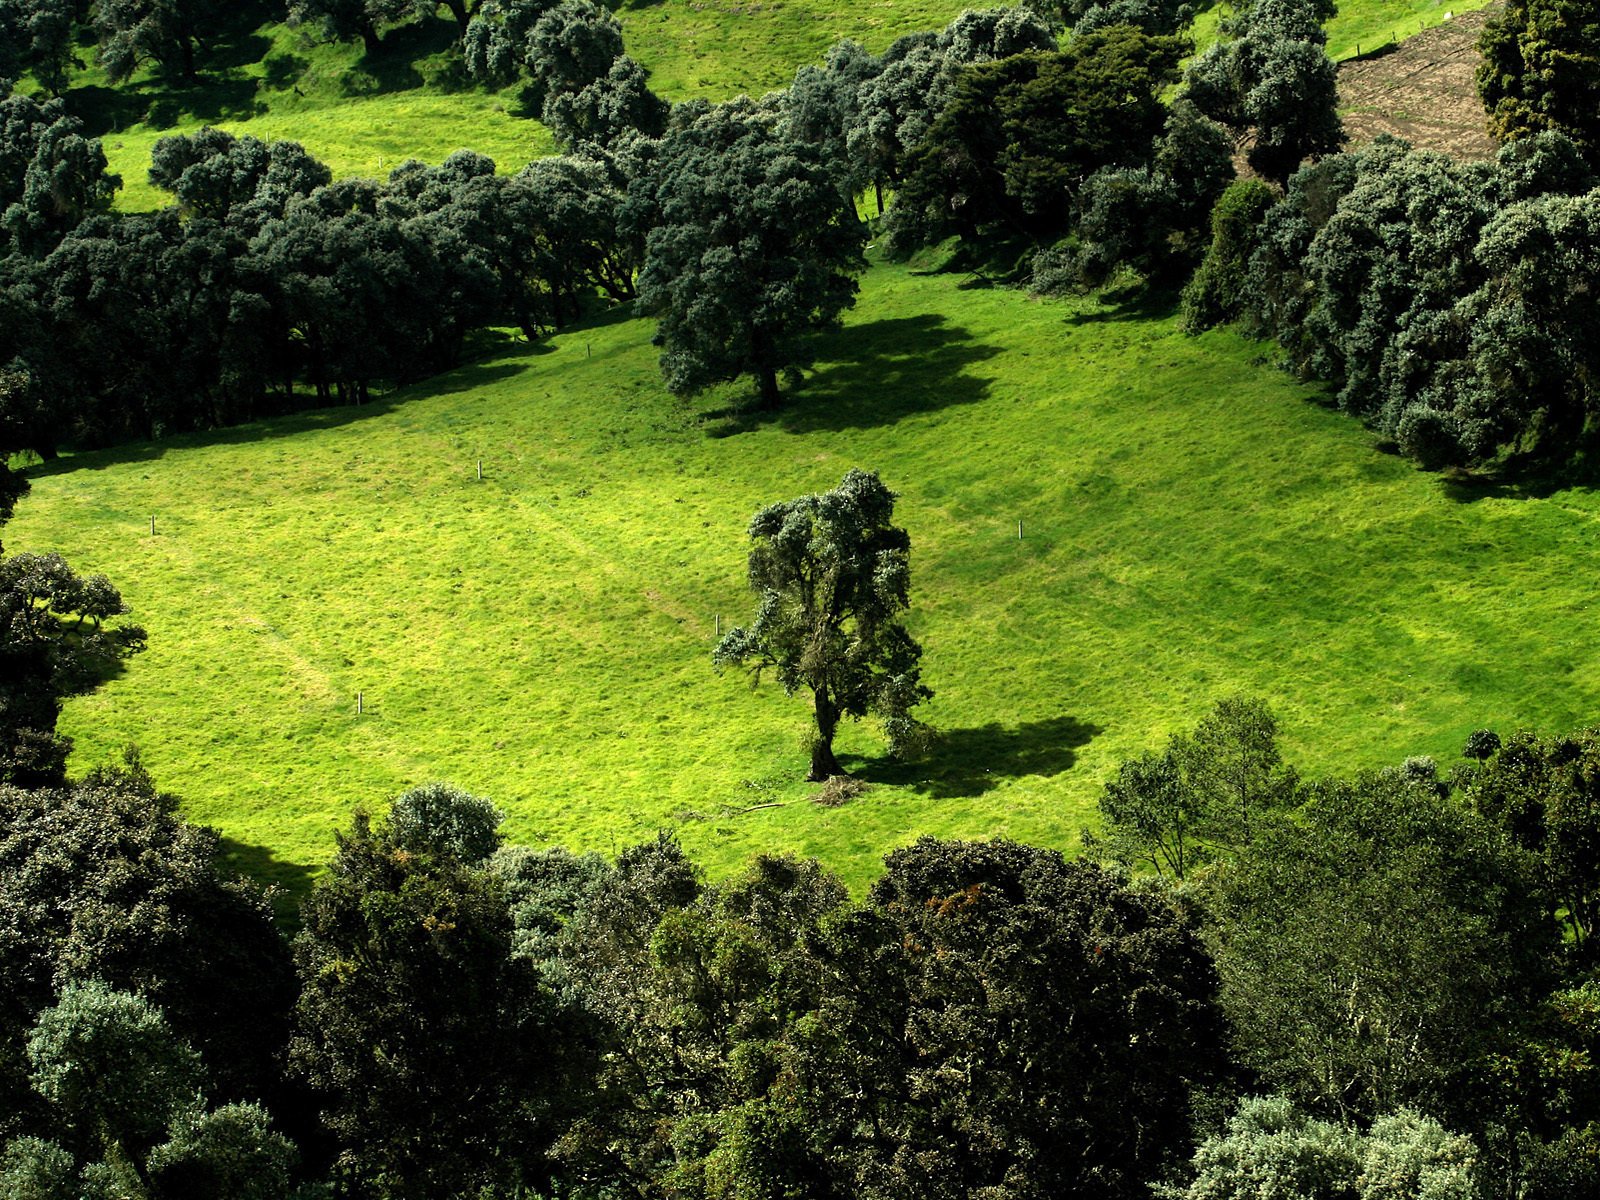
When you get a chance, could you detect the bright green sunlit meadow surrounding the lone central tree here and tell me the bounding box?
[5,266,1600,885]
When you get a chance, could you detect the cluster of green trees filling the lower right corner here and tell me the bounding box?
[1086,698,1600,1200]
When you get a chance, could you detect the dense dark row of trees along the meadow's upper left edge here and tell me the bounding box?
[0,109,635,458]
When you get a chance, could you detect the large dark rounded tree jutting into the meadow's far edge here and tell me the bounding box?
[626,101,866,406]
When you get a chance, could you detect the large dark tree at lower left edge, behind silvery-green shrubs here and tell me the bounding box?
[0,760,294,1120]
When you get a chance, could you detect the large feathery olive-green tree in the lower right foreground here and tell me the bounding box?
[1210,770,1557,1120]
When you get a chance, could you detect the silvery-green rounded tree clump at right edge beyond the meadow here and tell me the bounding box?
[1186,133,1600,467]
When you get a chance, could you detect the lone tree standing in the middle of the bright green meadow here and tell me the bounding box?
[714,467,933,781]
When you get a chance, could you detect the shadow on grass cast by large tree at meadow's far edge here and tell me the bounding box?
[706,314,1000,437]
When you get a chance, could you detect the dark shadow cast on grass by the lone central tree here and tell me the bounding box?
[845,717,1104,800]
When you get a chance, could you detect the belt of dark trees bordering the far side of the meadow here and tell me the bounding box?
[9,0,1600,469]
